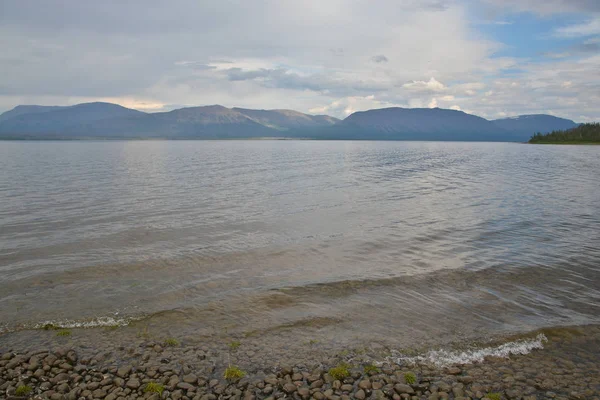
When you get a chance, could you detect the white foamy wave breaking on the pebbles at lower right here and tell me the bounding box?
[388,333,548,367]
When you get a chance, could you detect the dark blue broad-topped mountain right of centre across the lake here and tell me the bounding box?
[325,107,515,141]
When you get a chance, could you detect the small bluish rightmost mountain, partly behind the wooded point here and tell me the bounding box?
[492,114,578,141]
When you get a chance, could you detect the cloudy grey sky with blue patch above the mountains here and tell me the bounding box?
[0,0,600,122]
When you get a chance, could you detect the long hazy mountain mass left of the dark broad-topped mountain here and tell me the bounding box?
[0,103,339,139]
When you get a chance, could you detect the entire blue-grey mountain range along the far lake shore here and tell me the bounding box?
[0,103,578,142]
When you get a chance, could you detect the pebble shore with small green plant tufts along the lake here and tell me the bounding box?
[0,326,600,400]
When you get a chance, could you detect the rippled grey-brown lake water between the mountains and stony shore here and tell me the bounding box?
[0,141,600,346]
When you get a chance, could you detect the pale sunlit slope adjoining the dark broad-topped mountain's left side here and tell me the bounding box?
[232,108,340,131]
